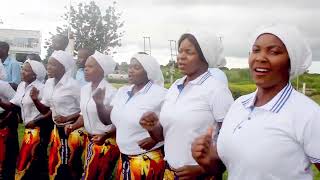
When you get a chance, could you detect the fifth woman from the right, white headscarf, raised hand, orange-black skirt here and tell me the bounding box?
[31,50,82,179]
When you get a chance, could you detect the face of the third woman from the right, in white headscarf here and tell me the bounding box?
[128,58,148,85]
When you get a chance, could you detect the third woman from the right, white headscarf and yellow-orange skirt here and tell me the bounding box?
[109,53,166,179]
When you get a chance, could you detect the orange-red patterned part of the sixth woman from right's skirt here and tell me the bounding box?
[15,128,40,180]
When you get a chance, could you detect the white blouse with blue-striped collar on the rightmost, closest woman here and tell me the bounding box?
[217,84,320,180]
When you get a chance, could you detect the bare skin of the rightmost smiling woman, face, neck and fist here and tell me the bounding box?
[192,34,320,172]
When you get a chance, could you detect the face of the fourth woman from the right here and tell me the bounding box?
[84,57,104,82]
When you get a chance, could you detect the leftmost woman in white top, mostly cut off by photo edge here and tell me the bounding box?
[0,80,19,180]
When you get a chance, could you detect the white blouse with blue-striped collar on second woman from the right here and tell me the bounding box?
[160,72,233,168]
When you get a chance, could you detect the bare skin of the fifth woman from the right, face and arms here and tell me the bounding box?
[30,57,79,123]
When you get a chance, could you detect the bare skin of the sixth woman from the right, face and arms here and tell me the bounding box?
[0,63,50,128]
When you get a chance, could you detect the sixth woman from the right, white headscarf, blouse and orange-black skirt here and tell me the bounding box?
[0,60,49,179]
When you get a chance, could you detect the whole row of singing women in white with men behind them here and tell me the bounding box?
[0,25,320,180]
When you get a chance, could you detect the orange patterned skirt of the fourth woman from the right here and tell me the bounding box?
[82,135,120,180]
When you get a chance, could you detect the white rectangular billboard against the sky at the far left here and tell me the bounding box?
[0,29,41,62]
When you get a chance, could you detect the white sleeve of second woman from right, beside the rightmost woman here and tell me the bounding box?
[209,86,234,122]
